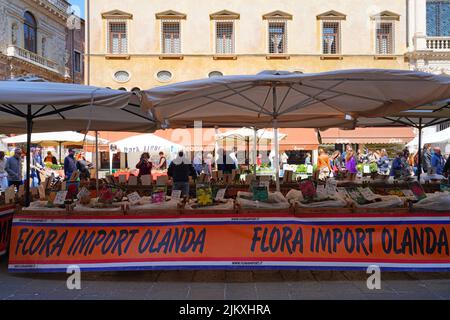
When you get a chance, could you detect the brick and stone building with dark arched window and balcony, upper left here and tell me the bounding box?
[0,0,82,82]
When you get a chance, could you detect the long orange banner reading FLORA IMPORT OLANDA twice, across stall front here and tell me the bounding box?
[9,214,450,272]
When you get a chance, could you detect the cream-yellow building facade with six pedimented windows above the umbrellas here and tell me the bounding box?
[85,0,409,90]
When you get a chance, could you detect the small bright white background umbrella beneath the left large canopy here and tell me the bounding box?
[2,131,108,162]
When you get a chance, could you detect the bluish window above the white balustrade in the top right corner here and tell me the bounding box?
[427,0,450,37]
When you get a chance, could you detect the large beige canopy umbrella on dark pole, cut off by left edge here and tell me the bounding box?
[0,81,155,206]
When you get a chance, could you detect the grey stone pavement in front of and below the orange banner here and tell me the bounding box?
[0,258,450,300]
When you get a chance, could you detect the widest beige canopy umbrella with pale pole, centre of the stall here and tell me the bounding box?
[143,69,450,189]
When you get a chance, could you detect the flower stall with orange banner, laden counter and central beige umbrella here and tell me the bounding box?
[3,70,450,272]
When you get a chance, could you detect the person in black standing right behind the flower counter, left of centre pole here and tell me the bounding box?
[167,151,197,196]
